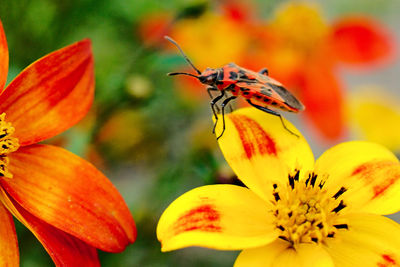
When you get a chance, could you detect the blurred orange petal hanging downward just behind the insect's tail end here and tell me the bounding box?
[300,56,344,140]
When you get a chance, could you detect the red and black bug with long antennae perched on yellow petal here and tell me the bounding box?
[165,36,305,140]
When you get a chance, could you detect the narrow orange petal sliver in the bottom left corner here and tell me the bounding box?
[0,203,19,267]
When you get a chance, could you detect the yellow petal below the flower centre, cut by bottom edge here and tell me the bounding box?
[234,239,334,267]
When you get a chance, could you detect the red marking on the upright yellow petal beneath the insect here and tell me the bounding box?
[229,114,277,159]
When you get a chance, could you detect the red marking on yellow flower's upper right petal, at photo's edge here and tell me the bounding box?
[352,161,400,199]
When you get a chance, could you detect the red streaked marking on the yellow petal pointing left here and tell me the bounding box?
[174,204,222,235]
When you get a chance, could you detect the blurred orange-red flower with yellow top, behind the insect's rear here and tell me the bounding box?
[247,2,393,140]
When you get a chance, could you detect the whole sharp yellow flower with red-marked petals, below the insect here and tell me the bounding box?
[157,108,400,267]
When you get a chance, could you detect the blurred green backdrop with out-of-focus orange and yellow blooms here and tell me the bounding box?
[0,0,400,266]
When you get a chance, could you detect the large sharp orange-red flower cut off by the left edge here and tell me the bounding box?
[0,19,136,266]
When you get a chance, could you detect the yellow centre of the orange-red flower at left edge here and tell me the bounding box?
[0,113,19,178]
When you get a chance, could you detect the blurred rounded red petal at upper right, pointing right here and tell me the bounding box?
[330,16,394,64]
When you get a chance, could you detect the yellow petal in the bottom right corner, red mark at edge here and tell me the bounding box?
[326,214,400,267]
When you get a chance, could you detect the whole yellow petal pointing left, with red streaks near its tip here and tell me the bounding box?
[157,185,277,251]
